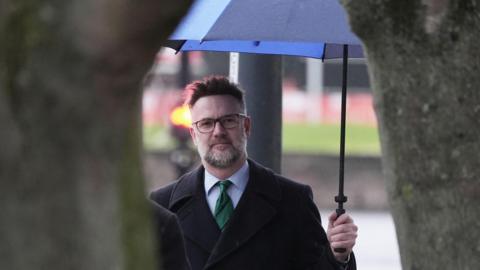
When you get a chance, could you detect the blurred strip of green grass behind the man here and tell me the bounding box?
[144,124,380,155]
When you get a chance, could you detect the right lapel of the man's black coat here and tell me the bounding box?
[204,160,281,269]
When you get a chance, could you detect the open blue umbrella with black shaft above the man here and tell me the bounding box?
[166,0,363,249]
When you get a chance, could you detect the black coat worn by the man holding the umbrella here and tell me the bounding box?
[151,160,356,270]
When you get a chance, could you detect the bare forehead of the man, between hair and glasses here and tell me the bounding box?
[191,95,243,121]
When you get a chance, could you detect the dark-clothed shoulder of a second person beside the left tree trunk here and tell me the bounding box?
[152,202,190,270]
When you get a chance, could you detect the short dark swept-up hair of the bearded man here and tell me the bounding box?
[185,76,245,109]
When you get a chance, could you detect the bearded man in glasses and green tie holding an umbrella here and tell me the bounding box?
[151,77,357,270]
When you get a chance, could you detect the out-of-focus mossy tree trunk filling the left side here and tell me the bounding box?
[0,0,189,270]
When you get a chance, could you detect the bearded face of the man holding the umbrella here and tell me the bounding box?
[190,95,250,168]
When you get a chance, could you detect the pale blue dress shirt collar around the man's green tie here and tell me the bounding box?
[204,161,249,214]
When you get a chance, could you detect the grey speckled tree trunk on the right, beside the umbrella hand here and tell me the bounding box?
[343,0,480,270]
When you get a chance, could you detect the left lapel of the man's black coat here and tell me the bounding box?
[169,168,221,253]
